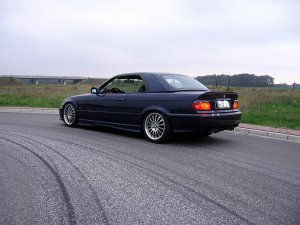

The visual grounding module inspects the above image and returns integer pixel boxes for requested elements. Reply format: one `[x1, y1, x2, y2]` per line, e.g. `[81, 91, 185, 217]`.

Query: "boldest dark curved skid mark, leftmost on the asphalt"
[0, 137, 77, 225]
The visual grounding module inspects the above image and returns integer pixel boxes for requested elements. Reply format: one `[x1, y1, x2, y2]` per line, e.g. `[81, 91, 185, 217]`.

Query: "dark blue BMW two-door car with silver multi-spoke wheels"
[59, 73, 241, 143]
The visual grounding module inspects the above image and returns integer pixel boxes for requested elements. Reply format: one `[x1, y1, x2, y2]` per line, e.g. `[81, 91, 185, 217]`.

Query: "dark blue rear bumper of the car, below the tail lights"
[168, 111, 242, 132]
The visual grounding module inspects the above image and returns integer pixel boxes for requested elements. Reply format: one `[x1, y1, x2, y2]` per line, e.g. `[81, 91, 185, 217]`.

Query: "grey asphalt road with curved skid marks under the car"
[0, 113, 300, 225]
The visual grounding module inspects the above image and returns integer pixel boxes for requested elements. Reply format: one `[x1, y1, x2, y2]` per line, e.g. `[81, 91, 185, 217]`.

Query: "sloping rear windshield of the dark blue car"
[161, 74, 208, 91]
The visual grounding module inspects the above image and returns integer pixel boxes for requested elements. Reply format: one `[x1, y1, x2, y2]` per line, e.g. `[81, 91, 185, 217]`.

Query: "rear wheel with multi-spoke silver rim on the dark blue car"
[143, 112, 171, 143]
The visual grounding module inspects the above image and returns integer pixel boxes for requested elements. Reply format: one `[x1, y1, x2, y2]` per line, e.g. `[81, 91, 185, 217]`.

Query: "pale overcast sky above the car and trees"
[0, 0, 300, 83]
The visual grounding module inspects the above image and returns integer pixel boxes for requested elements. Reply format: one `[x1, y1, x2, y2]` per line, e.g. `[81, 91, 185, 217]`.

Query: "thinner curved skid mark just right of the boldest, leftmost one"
[8, 132, 109, 225]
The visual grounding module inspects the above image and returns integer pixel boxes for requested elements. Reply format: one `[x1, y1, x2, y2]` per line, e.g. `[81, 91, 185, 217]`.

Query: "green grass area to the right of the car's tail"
[210, 87, 300, 130]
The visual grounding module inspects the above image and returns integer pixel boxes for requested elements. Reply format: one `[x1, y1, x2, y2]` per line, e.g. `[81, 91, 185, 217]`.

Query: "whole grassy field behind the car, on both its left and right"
[0, 82, 300, 130]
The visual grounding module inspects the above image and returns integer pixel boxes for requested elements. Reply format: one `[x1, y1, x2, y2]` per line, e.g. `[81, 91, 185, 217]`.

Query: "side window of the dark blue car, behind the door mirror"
[100, 76, 145, 93]
